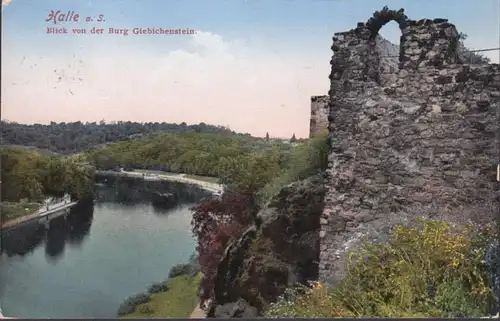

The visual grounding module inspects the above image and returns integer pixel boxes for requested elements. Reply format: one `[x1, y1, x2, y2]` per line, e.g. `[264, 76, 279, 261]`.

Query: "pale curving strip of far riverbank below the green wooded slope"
[97, 170, 223, 193]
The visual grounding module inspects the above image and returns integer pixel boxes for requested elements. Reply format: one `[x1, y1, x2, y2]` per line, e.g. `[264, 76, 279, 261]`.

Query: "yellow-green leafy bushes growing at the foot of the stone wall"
[266, 220, 495, 318]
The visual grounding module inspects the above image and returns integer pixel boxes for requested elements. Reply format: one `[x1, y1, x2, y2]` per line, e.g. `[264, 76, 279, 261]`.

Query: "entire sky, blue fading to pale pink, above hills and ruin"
[2, 0, 500, 136]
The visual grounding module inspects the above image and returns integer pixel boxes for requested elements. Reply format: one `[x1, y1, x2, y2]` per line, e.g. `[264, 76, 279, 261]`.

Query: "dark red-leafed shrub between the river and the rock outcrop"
[191, 192, 254, 300]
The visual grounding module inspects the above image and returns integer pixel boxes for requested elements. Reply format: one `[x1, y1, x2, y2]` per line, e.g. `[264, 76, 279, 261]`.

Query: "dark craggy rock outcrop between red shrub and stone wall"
[208, 176, 326, 317]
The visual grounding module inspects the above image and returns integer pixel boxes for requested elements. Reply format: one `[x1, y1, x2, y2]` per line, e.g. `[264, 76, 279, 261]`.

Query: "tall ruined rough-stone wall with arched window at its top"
[319, 8, 500, 283]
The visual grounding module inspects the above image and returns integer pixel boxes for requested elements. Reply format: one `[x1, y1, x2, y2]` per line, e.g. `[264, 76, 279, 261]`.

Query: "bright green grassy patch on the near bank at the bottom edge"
[124, 273, 202, 318]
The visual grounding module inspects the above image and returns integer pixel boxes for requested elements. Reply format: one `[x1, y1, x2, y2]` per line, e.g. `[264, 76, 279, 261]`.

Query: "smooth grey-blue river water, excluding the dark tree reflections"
[0, 184, 199, 318]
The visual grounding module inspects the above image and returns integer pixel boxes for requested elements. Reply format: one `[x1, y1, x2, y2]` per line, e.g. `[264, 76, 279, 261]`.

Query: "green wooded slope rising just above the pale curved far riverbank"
[85, 133, 293, 177]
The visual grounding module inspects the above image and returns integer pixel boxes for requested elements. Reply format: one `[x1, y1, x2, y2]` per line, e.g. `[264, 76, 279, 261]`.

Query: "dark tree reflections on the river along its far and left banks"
[0, 177, 210, 262]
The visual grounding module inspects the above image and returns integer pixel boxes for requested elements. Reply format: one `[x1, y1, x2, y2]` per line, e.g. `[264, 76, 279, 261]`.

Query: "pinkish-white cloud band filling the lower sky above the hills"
[2, 32, 330, 137]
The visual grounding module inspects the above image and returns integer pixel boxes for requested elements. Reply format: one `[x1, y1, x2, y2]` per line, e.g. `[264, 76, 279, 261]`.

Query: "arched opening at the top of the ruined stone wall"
[374, 21, 401, 78]
